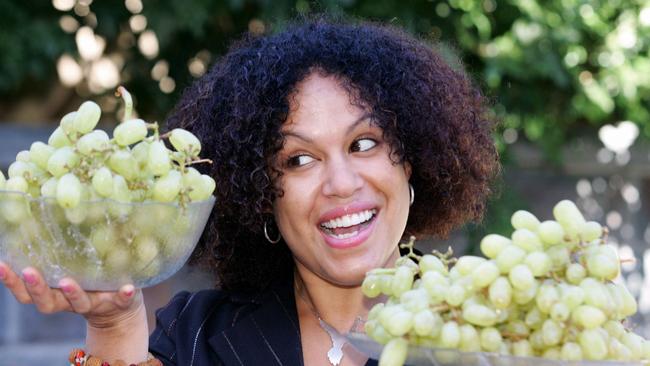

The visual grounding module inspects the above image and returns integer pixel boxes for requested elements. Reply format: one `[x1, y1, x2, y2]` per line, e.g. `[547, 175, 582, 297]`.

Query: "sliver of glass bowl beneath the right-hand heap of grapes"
[345, 332, 647, 366]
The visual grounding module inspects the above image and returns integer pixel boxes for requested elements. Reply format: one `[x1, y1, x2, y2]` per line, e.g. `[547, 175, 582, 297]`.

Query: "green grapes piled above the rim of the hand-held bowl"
[0, 88, 215, 209]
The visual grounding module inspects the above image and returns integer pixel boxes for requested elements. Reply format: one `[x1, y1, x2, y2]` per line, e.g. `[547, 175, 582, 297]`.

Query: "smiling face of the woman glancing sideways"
[274, 73, 410, 286]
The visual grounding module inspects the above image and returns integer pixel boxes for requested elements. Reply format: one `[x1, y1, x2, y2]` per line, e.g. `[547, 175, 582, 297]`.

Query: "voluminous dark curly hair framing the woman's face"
[167, 18, 499, 291]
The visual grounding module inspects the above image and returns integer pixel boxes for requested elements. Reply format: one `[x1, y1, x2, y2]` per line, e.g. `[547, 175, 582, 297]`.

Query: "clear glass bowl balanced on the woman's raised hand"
[0, 190, 215, 291]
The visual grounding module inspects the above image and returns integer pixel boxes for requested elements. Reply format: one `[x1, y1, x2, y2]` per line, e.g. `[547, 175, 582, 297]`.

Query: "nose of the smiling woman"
[323, 157, 363, 198]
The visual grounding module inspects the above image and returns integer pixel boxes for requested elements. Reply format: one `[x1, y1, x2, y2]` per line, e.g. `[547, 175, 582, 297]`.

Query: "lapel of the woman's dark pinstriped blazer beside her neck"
[208, 279, 303, 366]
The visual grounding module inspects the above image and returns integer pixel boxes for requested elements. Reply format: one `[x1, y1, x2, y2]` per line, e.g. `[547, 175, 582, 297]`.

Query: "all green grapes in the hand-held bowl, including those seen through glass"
[0, 87, 215, 284]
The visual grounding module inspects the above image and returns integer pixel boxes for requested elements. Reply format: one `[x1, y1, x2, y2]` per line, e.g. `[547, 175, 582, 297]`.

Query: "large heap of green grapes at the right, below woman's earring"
[362, 200, 650, 366]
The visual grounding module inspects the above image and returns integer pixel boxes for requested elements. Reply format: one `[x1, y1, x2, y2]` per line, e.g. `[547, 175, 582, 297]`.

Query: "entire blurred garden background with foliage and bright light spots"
[0, 0, 650, 363]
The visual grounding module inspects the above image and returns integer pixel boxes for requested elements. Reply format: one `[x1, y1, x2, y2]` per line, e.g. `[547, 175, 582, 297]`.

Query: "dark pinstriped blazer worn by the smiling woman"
[149, 278, 377, 366]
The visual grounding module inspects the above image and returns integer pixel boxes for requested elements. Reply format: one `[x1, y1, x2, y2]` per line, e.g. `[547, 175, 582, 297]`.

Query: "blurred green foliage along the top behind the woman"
[0, 0, 650, 244]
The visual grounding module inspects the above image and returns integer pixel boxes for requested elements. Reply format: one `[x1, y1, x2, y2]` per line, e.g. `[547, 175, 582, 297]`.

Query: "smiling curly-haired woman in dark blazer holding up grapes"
[0, 20, 498, 365]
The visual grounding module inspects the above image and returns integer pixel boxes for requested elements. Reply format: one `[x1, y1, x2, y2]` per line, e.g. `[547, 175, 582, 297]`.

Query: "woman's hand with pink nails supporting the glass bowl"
[0, 262, 143, 328]
